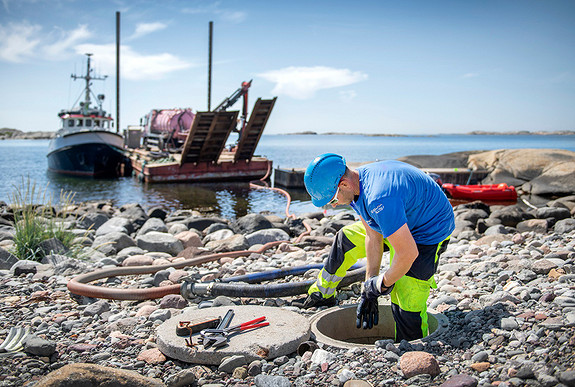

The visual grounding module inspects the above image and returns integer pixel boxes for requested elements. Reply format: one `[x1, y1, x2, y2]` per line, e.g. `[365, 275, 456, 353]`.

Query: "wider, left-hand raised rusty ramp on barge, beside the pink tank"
[180, 111, 238, 165]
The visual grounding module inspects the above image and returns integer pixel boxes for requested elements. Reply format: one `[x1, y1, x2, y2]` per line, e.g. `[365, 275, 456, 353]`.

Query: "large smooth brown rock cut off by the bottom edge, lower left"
[34, 363, 165, 387]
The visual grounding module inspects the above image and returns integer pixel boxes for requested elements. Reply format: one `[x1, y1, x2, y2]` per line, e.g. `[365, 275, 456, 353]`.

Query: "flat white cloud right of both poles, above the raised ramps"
[259, 66, 368, 99]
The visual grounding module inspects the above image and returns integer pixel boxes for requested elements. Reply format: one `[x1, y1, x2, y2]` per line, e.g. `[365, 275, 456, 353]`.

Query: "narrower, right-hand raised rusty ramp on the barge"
[234, 97, 277, 161]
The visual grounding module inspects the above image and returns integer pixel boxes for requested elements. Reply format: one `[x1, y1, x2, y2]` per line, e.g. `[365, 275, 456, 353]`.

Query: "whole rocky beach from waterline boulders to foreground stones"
[0, 149, 575, 387]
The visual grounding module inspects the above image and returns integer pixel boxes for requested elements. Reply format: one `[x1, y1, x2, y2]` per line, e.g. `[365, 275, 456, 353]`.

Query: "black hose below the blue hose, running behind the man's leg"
[180, 267, 365, 300]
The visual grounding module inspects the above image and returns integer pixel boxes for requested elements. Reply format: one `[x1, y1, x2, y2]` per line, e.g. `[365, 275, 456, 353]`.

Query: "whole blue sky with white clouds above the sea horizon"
[0, 0, 575, 135]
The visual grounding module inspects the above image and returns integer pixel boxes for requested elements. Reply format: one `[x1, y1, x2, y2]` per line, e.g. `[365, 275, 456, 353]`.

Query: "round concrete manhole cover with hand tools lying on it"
[156, 305, 311, 365]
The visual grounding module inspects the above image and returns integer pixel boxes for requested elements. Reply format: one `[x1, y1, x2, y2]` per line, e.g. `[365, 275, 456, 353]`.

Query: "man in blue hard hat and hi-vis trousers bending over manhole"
[304, 153, 455, 341]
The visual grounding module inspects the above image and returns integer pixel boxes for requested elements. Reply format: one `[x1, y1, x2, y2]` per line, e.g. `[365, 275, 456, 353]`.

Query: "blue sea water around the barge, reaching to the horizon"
[0, 135, 575, 219]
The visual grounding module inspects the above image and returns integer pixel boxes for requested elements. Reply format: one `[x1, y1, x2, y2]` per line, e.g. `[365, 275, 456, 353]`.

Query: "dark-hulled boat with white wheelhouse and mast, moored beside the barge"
[47, 54, 129, 178]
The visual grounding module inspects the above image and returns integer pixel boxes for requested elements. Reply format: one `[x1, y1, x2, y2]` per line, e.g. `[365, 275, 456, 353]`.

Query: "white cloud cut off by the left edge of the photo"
[0, 22, 42, 63]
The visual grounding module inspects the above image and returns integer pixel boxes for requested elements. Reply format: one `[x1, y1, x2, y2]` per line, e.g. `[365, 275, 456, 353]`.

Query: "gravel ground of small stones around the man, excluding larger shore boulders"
[0, 202, 575, 387]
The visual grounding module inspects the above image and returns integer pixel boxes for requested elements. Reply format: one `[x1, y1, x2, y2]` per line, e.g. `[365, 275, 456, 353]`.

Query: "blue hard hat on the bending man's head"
[303, 153, 346, 207]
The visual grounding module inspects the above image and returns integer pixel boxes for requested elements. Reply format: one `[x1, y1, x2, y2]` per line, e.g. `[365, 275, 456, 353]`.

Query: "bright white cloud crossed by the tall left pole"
[72, 44, 192, 80]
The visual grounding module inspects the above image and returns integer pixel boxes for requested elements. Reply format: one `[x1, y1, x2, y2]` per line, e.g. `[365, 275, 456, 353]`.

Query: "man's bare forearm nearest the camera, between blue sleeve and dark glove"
[382, 223, 419, 286]
